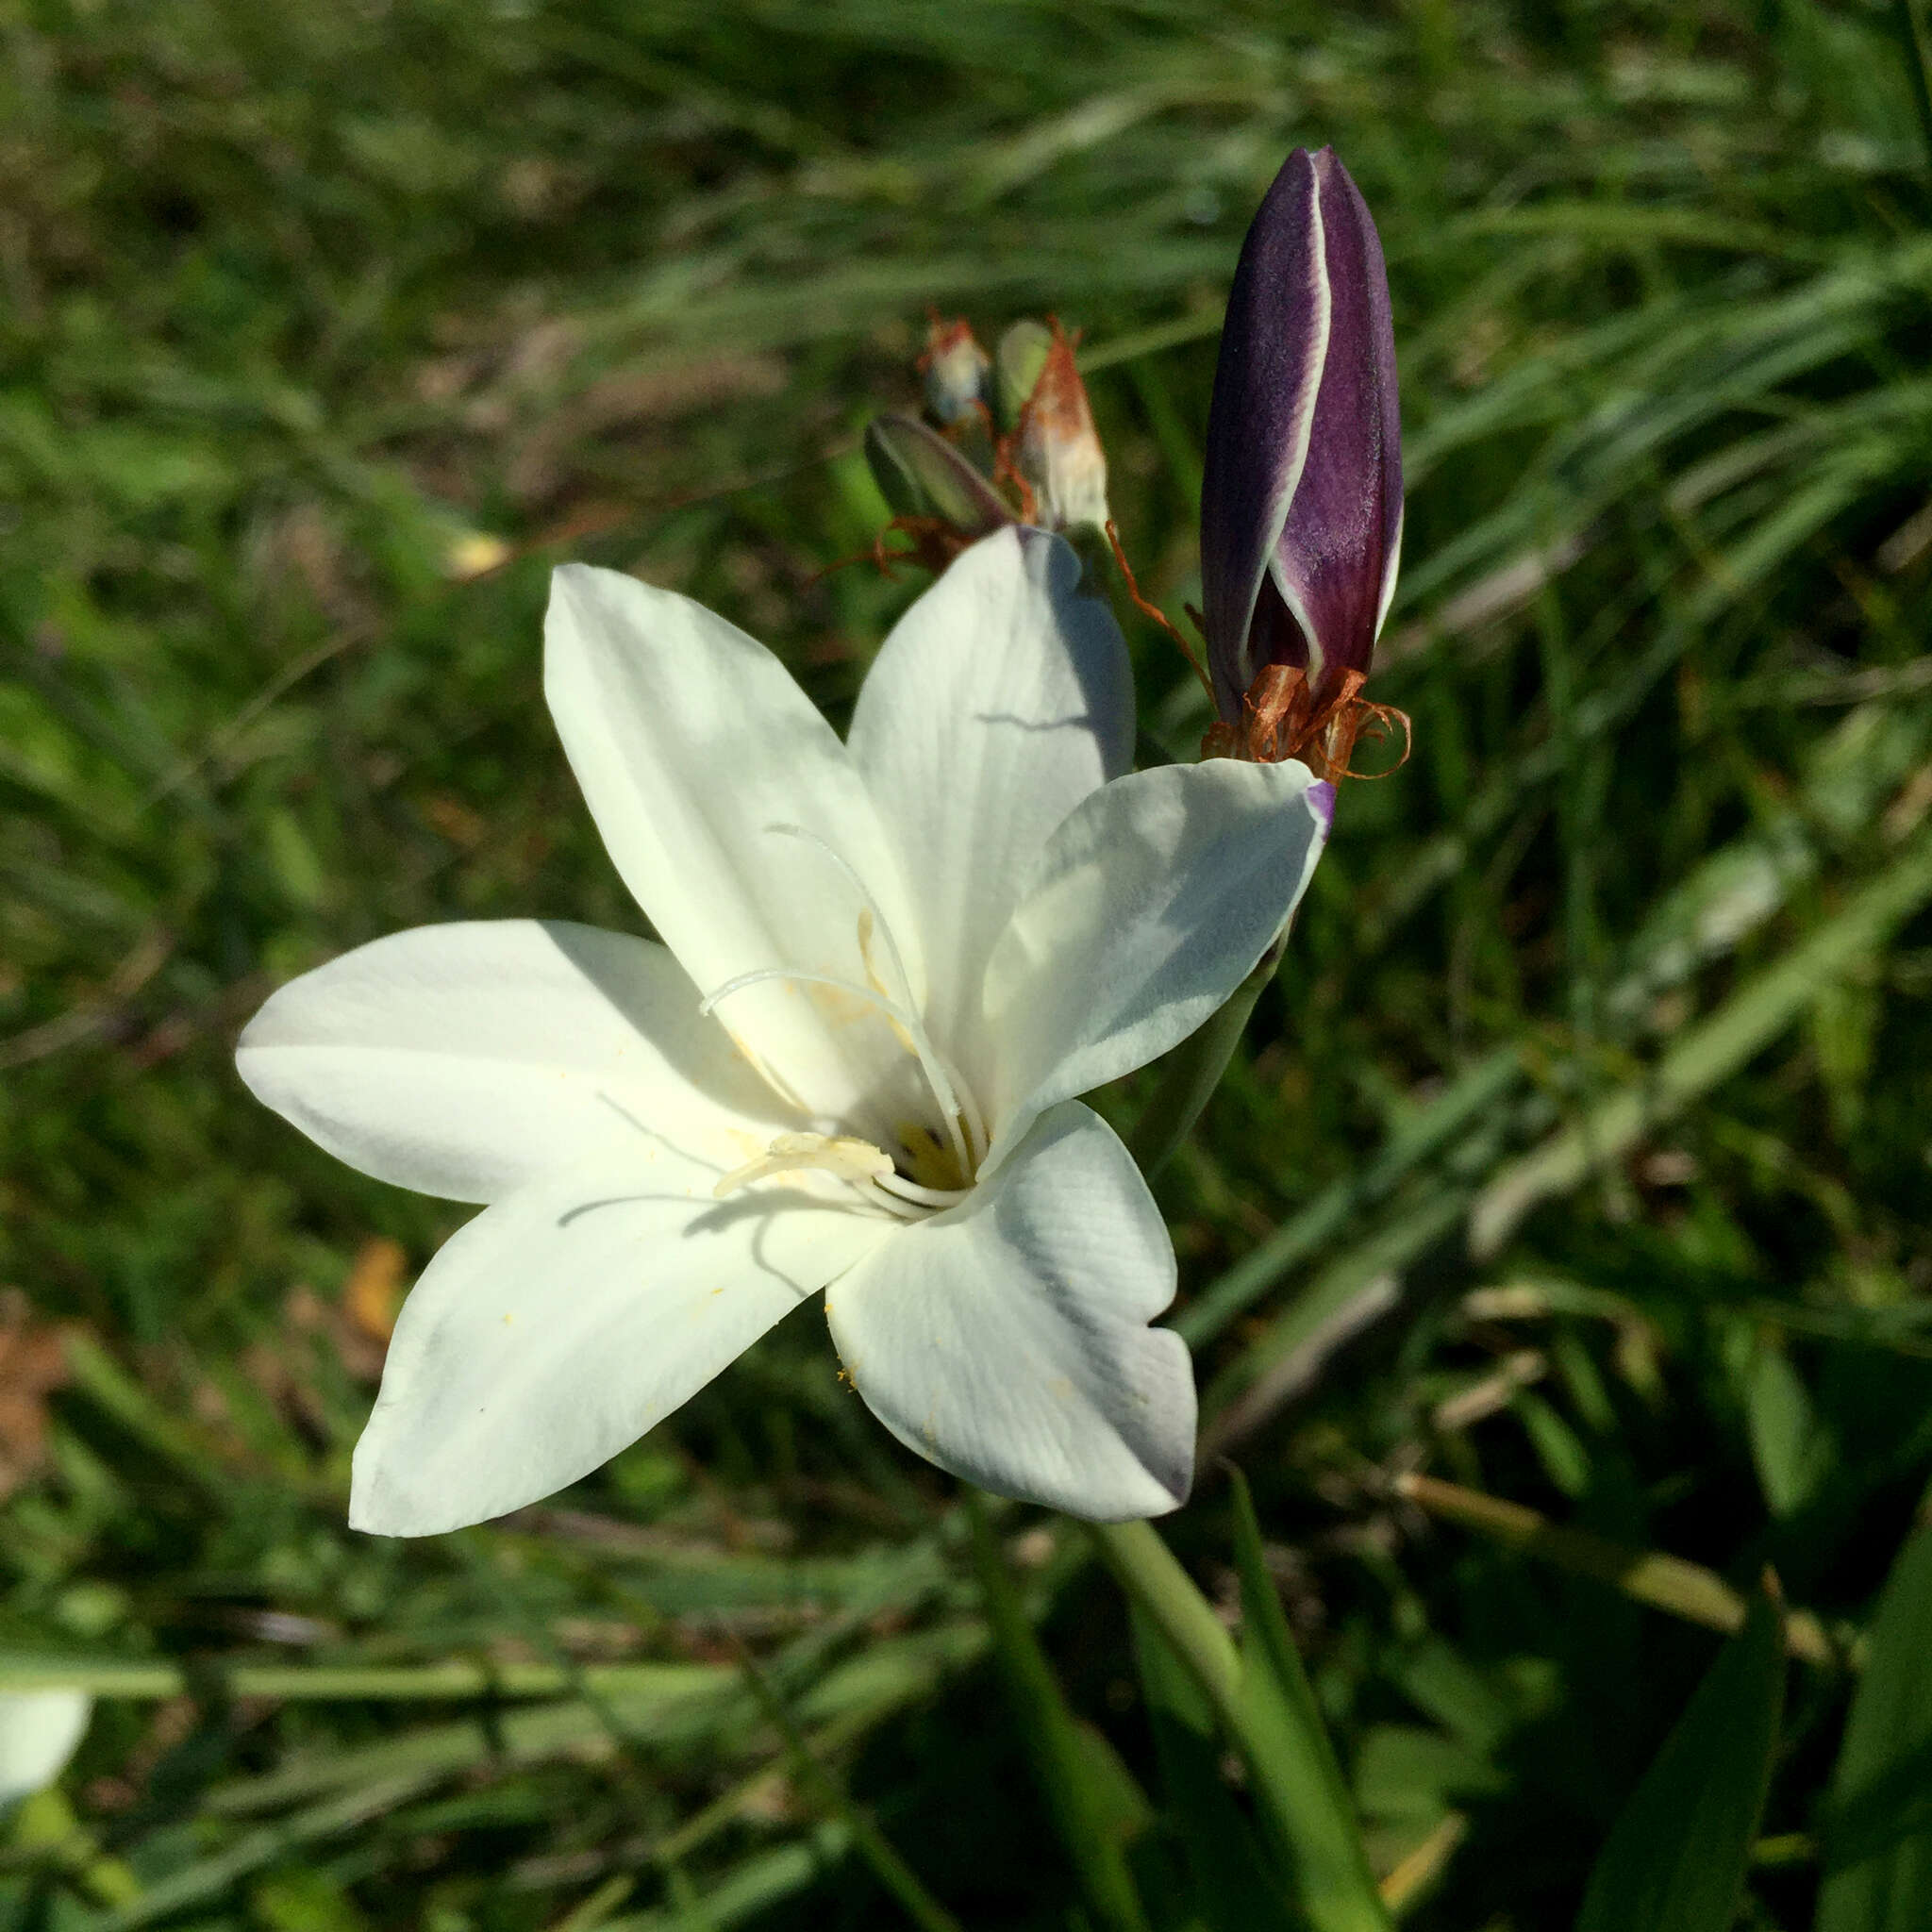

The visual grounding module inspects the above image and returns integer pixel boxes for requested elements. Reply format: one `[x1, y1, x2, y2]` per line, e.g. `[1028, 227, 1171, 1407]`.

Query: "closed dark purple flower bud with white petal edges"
[1202, 149, 1403, 728]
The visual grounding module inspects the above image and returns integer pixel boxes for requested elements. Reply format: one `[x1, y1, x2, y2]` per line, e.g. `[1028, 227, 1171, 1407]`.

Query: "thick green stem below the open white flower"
[1090, 1523, 1390, 1932]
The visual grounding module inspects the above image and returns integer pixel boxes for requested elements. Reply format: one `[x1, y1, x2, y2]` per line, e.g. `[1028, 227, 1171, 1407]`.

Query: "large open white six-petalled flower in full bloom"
[238, 529, 1329, 1536]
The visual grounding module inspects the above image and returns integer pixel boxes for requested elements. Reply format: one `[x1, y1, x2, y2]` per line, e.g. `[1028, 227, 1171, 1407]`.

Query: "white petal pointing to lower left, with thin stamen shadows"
[350, 1156, 900, 1536]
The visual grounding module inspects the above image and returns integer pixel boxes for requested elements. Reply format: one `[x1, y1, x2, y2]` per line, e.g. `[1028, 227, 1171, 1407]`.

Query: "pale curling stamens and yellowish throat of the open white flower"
[697, 824, 988, 1219]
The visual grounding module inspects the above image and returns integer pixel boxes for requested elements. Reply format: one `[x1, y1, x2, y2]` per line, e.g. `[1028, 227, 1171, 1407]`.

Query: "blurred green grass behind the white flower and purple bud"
[0, 0, 1932, 1932]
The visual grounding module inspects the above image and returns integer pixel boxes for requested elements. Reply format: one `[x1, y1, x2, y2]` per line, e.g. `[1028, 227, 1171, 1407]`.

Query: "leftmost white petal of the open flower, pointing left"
[236, 920, 796, 1202]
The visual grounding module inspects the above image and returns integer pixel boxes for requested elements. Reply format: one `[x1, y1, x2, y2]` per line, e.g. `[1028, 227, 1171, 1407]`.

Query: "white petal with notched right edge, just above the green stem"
[824, 1105, 1194, 1523]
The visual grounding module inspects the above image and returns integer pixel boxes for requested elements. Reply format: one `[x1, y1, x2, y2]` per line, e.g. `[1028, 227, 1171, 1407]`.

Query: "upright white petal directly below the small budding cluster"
[850, 527, 1134, 1086]
